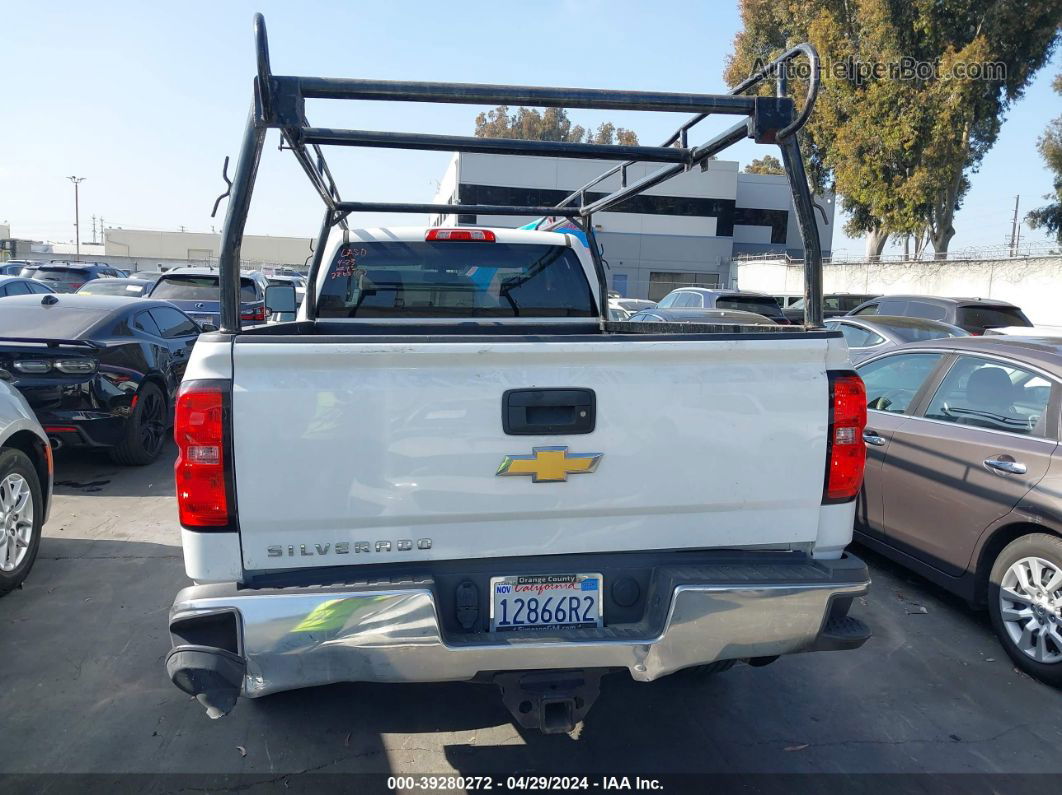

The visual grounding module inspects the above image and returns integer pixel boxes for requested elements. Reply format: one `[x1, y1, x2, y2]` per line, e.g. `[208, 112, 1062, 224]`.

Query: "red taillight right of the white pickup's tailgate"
[822, 370, 867, 505]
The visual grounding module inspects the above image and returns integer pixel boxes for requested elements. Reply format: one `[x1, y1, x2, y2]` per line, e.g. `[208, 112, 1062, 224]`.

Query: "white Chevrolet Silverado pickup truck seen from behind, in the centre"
[167, 15, 869, 731]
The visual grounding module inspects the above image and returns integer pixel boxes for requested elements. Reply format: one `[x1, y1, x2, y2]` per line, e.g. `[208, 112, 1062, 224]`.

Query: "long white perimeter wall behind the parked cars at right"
[737, 256, 1062, 325]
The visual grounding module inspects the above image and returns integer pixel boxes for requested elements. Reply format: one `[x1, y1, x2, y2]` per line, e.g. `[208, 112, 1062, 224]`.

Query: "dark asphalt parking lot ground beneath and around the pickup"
[0, 449, 1062, 790]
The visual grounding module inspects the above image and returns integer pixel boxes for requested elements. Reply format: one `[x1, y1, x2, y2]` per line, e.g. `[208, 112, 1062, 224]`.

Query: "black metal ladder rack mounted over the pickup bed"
[219, 14, 822, 333]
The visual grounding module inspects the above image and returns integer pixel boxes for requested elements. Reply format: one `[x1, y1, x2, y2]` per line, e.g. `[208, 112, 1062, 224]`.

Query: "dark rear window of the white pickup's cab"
[318, 240, 597, 317]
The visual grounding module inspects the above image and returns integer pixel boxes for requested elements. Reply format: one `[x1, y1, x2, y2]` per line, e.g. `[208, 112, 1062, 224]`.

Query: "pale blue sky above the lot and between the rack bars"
[0, 0, 1062, 255]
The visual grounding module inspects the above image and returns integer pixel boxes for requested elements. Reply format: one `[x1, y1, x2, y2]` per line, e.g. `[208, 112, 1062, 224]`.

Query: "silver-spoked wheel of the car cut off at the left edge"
[0, 449, 45, 595]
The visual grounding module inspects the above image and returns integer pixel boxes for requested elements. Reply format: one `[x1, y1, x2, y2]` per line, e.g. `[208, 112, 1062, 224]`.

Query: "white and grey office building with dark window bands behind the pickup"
[431, 153, 834, 300]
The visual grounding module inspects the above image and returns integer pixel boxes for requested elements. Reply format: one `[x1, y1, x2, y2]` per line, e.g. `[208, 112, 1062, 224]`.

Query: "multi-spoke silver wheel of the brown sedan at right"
[989, 533, 1062, 687]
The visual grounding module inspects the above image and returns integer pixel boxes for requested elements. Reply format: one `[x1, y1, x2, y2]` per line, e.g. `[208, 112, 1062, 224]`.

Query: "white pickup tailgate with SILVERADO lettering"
[233, 335, 828, 571]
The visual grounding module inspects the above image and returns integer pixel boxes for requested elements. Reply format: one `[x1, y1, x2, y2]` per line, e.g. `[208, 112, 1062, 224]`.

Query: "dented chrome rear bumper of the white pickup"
[168, 557, 869, 701]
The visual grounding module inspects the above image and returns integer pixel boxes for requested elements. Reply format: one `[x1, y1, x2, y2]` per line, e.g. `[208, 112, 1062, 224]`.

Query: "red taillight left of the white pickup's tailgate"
[173, 381, 229, 528]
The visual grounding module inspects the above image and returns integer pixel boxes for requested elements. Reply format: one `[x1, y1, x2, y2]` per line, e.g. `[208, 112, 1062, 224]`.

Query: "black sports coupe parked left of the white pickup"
[0, 295, 201, 464]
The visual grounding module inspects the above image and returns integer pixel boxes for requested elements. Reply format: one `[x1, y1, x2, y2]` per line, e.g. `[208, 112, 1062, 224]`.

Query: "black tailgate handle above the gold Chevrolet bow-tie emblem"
[501, 387, 597, 436]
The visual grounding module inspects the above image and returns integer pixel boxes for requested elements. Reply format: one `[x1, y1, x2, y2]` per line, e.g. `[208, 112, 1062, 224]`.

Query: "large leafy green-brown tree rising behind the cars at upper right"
[725, 0, 1062, 257]
